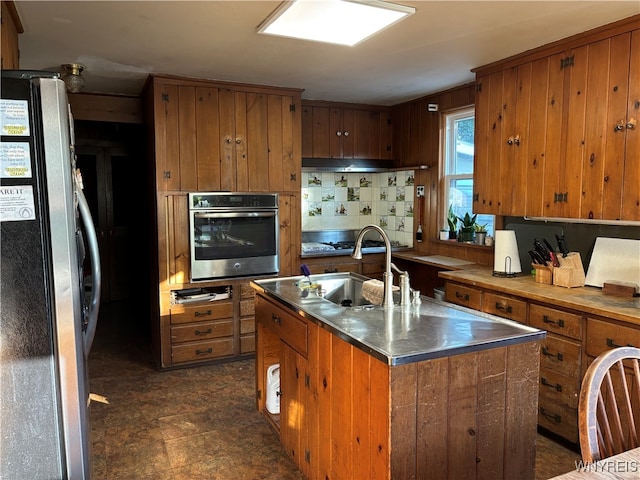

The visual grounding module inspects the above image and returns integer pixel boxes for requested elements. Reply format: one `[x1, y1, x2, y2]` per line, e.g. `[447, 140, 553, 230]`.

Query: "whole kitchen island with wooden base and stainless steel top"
[251, 274, 545, 479]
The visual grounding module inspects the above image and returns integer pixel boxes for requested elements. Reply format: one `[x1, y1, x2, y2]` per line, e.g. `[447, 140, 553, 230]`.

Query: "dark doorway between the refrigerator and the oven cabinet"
[75, 121, 149, 303]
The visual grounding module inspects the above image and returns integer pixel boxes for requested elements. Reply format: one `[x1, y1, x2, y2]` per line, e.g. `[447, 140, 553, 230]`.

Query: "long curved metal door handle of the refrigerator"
[75, 186, 102, 358]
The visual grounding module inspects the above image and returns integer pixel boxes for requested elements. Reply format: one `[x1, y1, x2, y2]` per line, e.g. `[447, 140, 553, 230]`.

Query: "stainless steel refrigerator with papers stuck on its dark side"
[0, 70, 100, 480]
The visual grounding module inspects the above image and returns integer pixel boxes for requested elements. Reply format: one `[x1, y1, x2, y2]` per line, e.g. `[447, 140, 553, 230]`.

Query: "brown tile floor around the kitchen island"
[89, 303, 579, 480]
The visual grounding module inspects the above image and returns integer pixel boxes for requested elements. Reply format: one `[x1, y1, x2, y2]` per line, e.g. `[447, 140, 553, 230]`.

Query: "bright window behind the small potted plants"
[443, 108, 495, 235]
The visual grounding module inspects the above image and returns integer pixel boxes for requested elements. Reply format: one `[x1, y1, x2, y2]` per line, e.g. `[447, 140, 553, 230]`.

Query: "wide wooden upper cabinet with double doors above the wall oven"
[150, 77, 301, 192]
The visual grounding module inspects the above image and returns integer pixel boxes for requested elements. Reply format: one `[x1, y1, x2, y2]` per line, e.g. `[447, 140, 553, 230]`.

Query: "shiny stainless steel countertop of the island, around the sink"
[251, 274, 546, 365]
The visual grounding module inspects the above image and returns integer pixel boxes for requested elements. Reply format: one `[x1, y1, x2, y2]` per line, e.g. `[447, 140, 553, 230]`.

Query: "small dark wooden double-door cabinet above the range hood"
[302, 102, 392, 160]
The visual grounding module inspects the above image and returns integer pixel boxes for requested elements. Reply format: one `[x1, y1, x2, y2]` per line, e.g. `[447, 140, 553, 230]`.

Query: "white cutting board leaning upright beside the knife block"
[585, 237, 640, 288]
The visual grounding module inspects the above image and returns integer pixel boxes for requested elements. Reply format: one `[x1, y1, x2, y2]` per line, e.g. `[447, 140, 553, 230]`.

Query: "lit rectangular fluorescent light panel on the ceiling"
[258, 0, 416, 46]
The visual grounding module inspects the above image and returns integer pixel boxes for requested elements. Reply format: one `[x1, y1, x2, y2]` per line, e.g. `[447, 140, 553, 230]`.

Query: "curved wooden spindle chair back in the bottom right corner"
[578, 347, 640, 462]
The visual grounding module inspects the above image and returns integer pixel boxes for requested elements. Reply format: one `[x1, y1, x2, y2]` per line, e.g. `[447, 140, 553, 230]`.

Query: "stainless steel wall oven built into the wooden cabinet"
[189, 192, 279, 281]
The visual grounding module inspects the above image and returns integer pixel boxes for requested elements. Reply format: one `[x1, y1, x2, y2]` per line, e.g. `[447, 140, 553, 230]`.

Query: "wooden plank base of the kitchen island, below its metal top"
[256, 294, 539, 480]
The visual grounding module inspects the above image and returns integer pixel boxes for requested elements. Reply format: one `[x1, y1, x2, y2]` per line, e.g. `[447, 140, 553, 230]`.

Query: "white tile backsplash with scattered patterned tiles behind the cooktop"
[302, 170, 415, 246]
